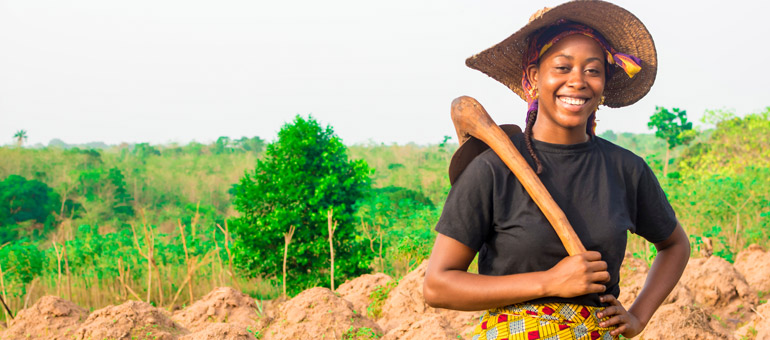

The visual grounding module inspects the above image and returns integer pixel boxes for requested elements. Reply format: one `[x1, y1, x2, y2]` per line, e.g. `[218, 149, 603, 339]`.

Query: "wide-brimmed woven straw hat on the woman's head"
[465, 0, 658, 107]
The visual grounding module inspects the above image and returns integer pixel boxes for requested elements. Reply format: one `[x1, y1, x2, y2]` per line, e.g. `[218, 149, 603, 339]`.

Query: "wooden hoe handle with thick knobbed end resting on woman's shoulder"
[452, 96, 586, 255]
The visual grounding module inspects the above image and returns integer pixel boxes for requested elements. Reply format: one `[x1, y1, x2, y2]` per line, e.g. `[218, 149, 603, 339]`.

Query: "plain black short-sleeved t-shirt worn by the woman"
[436, 134, 677, 306]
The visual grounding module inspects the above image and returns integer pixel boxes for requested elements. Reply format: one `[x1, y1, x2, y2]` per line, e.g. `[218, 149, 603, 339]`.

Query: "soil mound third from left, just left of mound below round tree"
[171, 287, 259, 332]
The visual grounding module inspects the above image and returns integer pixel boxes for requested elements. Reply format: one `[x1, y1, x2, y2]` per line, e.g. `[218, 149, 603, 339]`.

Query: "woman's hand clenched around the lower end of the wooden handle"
[546, 251, 610, 298]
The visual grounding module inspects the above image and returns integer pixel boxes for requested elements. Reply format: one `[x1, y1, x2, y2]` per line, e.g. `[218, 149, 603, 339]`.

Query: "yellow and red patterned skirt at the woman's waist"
[471, 303, 618, 340]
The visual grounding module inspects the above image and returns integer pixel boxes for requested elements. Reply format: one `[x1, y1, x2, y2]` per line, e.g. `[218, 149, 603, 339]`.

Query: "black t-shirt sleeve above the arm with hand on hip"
[635, 163, 677, 243]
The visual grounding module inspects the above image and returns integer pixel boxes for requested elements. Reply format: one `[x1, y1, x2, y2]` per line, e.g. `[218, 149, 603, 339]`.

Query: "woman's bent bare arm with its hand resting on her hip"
[599, 223, 690, 338]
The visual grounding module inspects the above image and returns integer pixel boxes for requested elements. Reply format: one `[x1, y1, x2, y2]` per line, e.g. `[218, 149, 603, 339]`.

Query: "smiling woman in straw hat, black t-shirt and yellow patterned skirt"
[423, 0, 689, 340]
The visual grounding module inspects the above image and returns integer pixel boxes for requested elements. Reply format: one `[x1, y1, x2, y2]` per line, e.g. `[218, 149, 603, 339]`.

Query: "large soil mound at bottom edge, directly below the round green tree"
[260, 287, 382, 340]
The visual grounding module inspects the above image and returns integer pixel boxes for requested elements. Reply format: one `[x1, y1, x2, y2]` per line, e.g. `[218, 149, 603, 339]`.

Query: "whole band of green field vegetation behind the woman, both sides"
[0, 109, 770, 326]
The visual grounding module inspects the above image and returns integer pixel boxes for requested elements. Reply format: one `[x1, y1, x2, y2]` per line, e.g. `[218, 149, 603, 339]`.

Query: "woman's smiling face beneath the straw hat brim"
[527, 34, 606, 136]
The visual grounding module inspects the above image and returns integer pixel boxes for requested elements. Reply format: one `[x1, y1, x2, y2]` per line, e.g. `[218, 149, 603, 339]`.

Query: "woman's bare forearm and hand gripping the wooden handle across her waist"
[423, 234, 610, 310]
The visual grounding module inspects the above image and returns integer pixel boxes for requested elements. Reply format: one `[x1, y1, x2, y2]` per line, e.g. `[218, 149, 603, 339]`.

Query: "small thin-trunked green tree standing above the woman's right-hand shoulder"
[647, 106, 696, 177]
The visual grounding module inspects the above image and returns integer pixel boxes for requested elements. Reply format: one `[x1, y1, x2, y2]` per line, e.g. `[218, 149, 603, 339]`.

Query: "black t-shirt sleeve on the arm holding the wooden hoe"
[436, 157, 494, 251]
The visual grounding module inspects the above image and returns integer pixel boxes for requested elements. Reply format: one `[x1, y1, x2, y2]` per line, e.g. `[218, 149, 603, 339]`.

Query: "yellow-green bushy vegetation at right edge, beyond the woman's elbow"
[662, 108, 770, 262]
